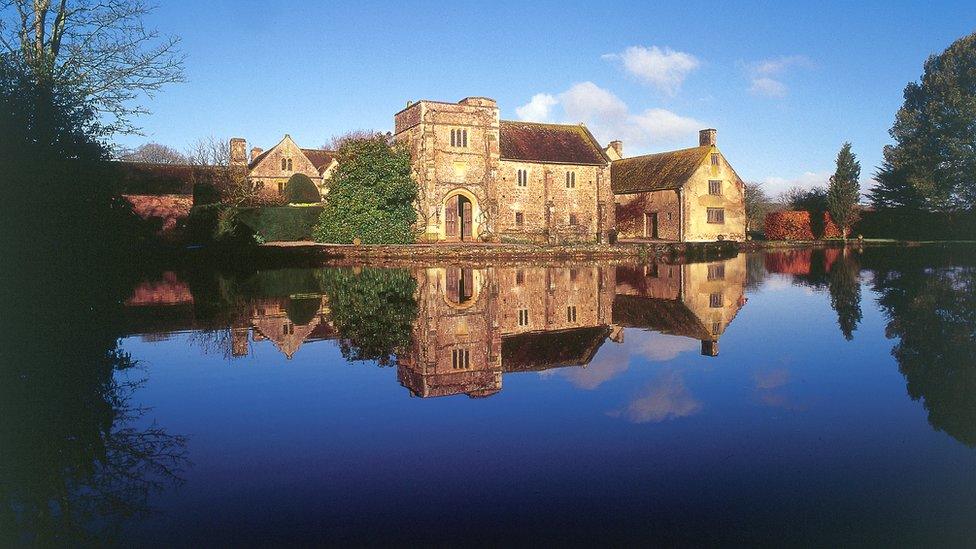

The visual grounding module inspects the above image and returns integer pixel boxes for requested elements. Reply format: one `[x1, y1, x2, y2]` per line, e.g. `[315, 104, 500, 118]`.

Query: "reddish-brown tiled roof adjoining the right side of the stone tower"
[499, 120, 610, 165]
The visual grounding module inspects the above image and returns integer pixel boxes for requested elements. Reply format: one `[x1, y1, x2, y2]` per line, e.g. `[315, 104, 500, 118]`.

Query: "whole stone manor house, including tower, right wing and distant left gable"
[231, 97, 745, 243]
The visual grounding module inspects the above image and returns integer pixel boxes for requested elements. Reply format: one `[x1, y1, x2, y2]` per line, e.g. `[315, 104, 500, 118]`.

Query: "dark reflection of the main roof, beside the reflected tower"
[502, 326, 610, 372]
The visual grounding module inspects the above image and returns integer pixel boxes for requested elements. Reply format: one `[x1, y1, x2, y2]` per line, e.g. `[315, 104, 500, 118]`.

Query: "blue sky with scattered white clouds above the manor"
[119, 0, 976, 194]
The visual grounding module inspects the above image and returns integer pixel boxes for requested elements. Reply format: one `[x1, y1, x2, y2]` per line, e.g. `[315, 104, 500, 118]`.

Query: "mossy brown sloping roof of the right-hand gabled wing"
[610, 146, 712, 194]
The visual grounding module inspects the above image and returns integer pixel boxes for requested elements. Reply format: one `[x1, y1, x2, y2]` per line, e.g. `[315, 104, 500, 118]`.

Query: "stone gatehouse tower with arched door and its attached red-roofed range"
[394, 97, 613, 242]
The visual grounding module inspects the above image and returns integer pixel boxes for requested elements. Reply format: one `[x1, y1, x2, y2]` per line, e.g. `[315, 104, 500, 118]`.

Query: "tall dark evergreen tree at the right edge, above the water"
[870, 34, 976, 212]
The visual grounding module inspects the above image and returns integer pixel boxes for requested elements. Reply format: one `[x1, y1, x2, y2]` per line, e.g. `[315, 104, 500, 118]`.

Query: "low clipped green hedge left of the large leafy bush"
[187, 204, 322, 244]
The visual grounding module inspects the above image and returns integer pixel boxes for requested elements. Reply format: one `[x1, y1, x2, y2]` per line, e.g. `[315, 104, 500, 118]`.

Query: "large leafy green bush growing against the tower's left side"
[313, 136, 417, 244]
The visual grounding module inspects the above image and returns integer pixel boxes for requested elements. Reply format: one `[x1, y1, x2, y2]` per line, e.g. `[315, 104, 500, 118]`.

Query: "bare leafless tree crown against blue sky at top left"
[0, 0, 184, 134]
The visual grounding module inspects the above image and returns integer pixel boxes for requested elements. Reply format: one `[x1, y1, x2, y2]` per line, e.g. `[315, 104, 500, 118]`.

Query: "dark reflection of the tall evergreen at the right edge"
[866, 248, 976, 446]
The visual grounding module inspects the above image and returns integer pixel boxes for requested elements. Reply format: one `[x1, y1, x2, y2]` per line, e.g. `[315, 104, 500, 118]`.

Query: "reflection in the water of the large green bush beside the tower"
[318, 268, 417, 365]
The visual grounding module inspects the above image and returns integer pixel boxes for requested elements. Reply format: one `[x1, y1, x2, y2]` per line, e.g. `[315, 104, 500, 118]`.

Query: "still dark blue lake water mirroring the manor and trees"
[0, 247, 976, 546]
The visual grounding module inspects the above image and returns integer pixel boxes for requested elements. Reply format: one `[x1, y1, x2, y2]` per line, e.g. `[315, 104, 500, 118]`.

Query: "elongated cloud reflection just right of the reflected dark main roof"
[542, 330, 699, 390]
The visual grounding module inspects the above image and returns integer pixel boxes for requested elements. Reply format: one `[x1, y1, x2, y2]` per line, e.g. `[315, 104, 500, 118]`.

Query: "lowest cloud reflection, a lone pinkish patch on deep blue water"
[610, 369, 702, 423]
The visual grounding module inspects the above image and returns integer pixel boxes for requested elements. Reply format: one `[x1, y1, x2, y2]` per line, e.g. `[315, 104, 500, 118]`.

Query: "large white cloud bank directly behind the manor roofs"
[515, 82, 706, 150]
